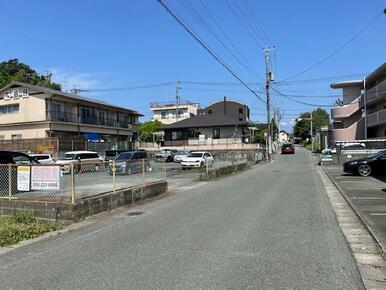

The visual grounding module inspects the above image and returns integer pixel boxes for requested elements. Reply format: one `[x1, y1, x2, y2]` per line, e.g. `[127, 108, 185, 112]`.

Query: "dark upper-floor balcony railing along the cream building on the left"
[47, 111, 132, 129]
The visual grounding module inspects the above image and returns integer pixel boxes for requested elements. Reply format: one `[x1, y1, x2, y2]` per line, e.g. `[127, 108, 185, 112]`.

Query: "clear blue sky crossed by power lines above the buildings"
[0, 0, 386, 129]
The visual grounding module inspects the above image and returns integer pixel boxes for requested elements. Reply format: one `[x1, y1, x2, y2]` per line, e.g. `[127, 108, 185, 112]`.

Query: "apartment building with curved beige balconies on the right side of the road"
[330, 63, 386, 143]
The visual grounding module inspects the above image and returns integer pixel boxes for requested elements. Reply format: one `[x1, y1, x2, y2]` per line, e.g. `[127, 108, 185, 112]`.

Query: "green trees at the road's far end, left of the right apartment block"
[293, 108, 330, 140]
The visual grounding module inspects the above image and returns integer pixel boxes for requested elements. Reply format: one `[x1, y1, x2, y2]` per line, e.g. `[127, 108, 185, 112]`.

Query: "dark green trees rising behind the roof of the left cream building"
[0, 58, 61, 90]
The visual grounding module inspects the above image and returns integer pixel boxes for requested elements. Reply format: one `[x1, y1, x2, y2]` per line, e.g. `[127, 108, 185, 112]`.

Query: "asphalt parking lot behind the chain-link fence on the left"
[0, 160, 199, 201]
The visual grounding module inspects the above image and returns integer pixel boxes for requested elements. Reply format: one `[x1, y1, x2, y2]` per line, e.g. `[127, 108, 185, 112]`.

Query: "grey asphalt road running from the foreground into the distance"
[0, 150, 363, 289]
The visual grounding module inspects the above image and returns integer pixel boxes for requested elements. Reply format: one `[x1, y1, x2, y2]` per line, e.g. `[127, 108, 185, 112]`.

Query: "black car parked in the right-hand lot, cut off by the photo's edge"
[343, 150, 386, 176]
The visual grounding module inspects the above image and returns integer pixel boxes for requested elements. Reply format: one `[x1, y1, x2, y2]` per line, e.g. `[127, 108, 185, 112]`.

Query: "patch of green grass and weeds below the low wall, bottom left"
[0, 209, 63, 247]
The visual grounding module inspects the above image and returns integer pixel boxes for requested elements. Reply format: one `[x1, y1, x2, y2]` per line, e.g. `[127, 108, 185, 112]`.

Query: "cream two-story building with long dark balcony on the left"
[0, 82, 142, 148]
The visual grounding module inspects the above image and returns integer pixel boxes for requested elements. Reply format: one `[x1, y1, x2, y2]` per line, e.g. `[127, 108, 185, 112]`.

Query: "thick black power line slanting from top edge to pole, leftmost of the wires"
[156, 0, 278, 113]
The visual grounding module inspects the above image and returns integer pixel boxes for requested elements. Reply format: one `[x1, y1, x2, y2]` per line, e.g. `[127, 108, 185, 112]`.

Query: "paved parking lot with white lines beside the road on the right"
[325, 166, 386, 251]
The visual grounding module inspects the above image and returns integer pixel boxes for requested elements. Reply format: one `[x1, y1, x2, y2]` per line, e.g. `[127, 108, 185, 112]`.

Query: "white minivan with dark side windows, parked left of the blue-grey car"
[56, 151, 103, 173]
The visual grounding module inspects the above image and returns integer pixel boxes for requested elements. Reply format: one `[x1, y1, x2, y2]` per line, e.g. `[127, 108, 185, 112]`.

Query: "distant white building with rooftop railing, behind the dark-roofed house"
[150, 101, 200, 125]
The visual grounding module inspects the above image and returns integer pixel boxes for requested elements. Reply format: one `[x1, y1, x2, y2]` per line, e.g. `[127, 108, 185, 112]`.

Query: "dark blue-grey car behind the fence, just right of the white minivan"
[109, 151, 151, 175]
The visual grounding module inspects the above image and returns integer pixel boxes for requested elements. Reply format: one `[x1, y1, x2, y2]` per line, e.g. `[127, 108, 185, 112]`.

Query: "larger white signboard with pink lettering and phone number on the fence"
[31, 166, 60, 190]
